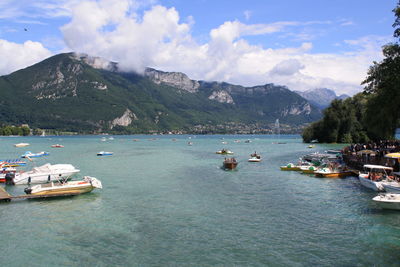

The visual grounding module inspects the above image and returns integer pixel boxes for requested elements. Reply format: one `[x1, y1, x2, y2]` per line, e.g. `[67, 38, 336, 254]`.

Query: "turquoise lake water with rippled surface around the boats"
[0, 136, 400, 266]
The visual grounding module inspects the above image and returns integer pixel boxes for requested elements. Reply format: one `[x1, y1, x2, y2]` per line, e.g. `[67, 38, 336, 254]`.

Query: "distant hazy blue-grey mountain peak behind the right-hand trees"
[294, 88, 350, 109]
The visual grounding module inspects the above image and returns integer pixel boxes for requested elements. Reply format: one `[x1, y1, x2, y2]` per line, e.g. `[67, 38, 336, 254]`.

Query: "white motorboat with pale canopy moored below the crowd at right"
[358, 164, 393, 192]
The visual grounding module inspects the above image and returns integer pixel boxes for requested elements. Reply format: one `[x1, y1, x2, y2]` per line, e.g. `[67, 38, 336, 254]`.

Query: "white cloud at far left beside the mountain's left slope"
[0, 39, 52, 75]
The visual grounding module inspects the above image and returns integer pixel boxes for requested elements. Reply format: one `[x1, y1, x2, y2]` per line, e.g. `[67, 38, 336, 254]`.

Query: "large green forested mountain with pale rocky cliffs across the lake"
[0, 53, 320, 133]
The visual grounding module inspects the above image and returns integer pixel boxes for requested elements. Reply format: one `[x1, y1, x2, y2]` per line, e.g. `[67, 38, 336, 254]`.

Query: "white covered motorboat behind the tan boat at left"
[13, 163, 80, 184]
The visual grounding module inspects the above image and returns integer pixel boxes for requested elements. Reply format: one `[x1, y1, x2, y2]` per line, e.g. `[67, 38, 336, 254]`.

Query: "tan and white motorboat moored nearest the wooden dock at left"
[24, 176, 103, 196]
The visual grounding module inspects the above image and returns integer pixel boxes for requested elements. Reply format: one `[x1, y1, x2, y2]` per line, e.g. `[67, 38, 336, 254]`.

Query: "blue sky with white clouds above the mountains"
[0, 0, 397, 94]
